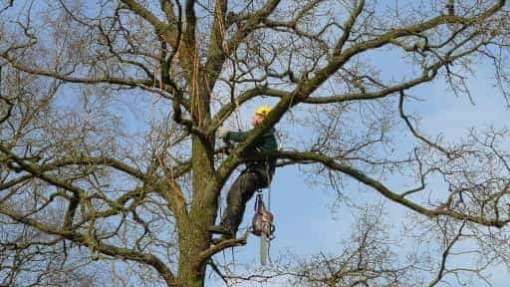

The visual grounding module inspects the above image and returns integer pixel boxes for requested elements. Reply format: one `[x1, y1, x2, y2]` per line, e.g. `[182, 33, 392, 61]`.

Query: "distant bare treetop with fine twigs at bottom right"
[213, 205, 500, 287]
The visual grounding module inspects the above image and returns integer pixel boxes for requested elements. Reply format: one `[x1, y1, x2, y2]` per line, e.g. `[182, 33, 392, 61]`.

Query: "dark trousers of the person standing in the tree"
[221, 170, 269, 234]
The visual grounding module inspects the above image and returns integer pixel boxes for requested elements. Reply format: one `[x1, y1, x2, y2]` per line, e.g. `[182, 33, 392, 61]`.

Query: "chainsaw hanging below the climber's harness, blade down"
[251, 190, 276, 265]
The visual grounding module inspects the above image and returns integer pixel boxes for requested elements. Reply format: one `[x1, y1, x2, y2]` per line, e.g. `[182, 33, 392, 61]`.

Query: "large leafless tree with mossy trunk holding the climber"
[0, 0, 510, 286]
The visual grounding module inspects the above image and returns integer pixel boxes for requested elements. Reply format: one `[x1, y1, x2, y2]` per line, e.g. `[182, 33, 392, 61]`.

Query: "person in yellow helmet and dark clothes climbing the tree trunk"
[209, 106, 278, 238]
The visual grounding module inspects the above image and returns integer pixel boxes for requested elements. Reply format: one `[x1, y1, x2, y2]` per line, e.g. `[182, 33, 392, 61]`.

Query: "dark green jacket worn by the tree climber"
[225, 128, 278, 182]
